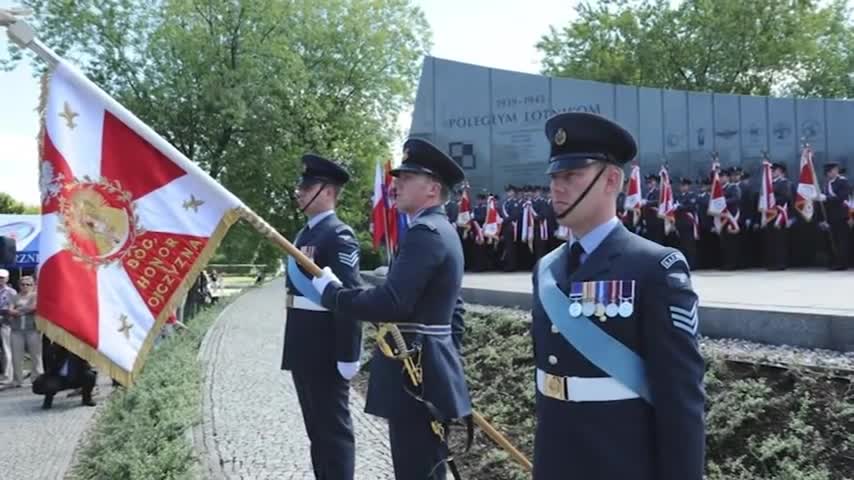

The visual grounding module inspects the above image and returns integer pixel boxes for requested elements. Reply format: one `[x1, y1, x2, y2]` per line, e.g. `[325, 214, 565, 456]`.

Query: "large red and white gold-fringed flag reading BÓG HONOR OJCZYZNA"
[37, 62, 243, 384]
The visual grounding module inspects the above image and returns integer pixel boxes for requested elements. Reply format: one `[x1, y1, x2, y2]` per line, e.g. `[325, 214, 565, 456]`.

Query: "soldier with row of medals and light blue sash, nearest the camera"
[531, 112, 705, 480]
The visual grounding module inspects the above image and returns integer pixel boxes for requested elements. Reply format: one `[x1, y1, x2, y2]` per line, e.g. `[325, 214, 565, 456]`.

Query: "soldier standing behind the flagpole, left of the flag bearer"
[282, 155, 362, 480]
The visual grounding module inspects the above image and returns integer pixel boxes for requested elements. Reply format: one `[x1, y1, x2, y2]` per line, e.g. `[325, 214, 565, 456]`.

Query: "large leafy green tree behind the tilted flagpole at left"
[5, 0, 429, 264]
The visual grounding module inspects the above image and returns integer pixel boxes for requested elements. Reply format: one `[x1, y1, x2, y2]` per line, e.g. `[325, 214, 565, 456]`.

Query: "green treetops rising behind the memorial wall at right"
[537, 0, 854, 97]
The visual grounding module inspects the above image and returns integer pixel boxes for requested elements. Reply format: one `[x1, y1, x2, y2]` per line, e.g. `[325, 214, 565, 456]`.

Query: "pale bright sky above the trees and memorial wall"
[0, 0, 579, 205]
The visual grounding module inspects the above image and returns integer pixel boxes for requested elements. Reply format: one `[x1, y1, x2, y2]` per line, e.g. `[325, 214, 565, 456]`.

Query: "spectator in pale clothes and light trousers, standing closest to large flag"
[6, 275, 44, 387]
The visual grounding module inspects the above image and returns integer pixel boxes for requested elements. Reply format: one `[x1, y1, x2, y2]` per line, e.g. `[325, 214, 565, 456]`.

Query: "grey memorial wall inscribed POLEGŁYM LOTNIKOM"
[410, 57, 854, 192]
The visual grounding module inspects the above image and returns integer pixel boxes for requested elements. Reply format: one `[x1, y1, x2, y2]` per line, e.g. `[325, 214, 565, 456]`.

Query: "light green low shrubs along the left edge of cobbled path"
[71, 304, 225, 480]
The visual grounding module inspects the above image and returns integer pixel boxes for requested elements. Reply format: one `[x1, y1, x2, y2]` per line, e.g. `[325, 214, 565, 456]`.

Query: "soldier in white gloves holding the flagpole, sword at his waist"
[312, 138, 471, 480]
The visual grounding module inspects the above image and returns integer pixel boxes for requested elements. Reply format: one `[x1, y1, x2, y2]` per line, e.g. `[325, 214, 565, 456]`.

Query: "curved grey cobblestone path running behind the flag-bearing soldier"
[194, 278, 393, 480]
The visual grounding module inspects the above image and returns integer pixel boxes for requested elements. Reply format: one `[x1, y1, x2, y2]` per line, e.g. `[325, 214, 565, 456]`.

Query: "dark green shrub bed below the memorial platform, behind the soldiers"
[448, 306, 854, 480]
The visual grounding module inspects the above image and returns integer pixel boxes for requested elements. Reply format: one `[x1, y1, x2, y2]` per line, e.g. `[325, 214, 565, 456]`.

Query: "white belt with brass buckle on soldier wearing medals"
[537, 368, 640, 402]
